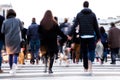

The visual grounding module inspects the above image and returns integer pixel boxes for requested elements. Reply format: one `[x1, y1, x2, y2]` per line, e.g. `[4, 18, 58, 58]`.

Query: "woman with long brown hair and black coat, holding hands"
[38, 10, 67, 73]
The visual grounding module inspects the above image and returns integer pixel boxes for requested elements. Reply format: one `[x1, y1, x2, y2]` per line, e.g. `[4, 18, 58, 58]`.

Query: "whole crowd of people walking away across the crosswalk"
[0, 1, 120, 74]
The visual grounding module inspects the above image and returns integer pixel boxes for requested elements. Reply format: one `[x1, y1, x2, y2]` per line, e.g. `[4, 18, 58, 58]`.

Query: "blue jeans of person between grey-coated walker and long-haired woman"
[30, 40, 40, 60]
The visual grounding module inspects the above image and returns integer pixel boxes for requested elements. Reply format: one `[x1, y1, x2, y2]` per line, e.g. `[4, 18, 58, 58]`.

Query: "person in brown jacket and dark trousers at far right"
[108, 22, 120, 64]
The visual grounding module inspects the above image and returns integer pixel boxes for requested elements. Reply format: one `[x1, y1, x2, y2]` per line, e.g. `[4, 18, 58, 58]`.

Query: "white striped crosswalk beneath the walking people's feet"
[0, 60, 120, 80]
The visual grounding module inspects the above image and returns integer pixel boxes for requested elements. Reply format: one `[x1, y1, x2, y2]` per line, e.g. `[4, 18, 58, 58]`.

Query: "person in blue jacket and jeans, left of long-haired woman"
[27, 18, 40, 64]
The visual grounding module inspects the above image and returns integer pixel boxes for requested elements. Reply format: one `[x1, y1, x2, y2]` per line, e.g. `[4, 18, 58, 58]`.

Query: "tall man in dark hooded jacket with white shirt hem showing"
[70, 1, 100, 72]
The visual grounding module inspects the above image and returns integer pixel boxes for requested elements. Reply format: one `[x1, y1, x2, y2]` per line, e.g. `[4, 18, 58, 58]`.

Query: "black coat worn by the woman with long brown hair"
[38, 25, 67, 53]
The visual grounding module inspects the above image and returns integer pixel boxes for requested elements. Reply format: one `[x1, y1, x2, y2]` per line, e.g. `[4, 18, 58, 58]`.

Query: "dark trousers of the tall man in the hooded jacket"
[81, 38, 95, 69]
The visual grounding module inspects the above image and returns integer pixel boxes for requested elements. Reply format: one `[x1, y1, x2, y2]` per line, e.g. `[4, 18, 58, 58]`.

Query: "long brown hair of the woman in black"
[40, 10, 57, 30]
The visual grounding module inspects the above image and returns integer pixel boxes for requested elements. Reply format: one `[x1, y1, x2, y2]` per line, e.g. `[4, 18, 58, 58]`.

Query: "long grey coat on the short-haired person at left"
[1, 17, 23, 54]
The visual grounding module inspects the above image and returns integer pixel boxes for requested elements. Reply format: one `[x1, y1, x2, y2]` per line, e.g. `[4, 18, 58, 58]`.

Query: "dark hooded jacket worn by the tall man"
[71, 8, 100, 39]
